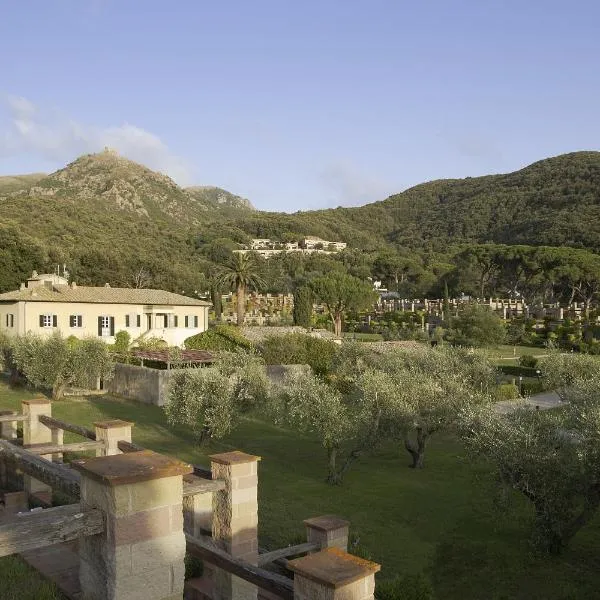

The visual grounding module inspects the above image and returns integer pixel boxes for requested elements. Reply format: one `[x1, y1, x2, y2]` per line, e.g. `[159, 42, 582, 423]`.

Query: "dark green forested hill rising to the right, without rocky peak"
[230, 152, 600, 251]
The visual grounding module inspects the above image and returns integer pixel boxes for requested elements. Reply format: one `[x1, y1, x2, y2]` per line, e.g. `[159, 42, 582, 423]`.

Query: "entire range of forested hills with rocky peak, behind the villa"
[0, 151, 600, 295]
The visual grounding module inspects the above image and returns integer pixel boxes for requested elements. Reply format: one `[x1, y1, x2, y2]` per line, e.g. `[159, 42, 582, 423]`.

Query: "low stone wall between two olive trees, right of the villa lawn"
[106, 363, 172, 406]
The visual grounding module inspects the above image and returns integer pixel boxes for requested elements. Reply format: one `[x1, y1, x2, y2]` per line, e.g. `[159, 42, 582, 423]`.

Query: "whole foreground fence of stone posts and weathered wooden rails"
[0, 398, 379, 600]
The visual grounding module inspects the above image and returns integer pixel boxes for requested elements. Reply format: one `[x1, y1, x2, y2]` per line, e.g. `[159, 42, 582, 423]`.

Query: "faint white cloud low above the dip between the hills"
[319, 162, 395, 206]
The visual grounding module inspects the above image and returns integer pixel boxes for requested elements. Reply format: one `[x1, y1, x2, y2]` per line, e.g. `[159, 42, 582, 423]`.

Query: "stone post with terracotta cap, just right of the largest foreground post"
[210, 451, 260, 600]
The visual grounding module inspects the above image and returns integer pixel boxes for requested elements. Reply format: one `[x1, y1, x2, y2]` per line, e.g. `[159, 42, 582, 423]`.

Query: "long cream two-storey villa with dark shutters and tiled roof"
[0, 271, 211, 346]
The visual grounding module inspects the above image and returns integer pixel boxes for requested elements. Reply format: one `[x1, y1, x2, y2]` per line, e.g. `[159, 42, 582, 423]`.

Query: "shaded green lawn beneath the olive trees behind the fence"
[0, 383, 600, 600]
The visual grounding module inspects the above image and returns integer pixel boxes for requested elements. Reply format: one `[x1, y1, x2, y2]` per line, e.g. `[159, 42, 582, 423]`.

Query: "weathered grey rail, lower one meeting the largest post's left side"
[0, 504, 104, 558]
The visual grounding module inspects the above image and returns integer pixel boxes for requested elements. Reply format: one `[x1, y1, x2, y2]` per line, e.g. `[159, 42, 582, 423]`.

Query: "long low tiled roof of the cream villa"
[0, 285, 210, 306]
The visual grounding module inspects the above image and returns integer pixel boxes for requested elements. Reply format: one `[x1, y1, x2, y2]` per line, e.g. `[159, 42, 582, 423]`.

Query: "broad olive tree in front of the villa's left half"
[11, 334, 113, 400]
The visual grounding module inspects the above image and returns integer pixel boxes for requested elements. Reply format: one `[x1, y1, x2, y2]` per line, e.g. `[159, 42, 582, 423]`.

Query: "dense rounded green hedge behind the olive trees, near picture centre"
[260, 333, 338, 375]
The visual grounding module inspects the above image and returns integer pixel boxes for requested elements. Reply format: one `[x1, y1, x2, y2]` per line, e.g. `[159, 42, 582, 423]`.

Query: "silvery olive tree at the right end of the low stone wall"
[165, 352, 269, 443]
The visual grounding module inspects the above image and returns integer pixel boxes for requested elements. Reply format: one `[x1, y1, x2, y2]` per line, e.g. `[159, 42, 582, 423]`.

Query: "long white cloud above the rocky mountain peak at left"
[0, 96, 191, 185]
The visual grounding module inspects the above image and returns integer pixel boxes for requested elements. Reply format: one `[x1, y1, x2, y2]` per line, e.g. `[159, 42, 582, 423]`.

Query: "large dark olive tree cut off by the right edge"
[464, 390, 600, 554]
